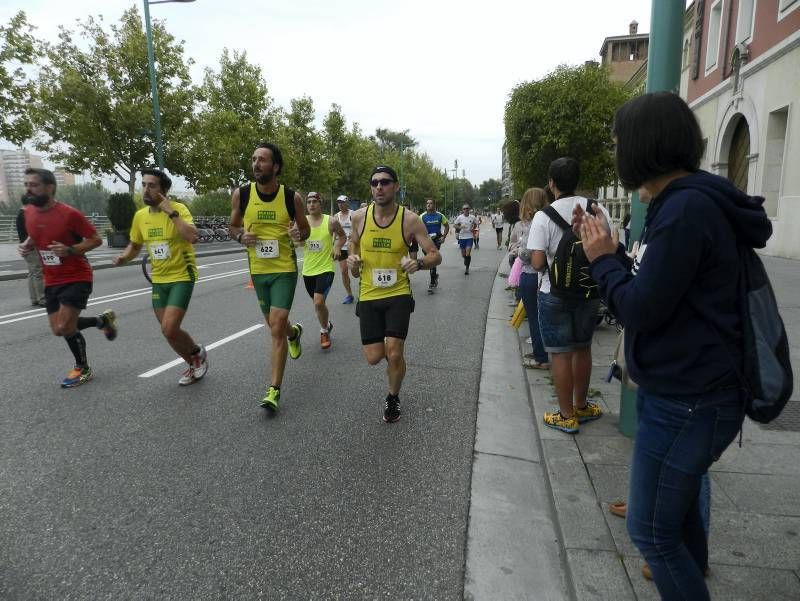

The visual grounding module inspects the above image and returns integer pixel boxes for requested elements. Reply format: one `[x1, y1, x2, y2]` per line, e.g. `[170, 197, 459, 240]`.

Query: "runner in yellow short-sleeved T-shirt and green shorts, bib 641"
[112, 169, 208, 386]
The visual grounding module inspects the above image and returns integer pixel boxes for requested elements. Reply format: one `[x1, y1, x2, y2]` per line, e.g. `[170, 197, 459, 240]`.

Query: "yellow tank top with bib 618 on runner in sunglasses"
[359, 204, 411, 301]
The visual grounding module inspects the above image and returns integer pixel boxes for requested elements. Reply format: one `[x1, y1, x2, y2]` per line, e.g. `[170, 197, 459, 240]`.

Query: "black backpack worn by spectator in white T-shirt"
[542, 200, 600, 300]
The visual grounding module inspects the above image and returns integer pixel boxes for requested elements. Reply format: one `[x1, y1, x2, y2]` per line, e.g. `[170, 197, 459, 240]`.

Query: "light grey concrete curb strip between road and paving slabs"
[464, 255, 576, 601]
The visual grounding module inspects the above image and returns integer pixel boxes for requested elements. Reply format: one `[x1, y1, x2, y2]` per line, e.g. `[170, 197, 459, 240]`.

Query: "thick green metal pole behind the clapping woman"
[619, 0, 686, 437]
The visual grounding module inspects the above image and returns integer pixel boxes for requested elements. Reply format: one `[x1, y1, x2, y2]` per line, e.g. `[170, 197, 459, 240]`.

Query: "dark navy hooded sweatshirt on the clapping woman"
[591, 171, 772, 396]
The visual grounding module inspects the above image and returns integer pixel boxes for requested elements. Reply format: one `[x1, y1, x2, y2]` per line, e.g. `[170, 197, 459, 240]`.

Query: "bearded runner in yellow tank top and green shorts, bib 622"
[230, 142, 310, 411]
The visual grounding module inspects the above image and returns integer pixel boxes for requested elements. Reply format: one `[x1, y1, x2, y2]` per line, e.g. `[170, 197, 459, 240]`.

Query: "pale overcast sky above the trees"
[0, 0, 651, 190]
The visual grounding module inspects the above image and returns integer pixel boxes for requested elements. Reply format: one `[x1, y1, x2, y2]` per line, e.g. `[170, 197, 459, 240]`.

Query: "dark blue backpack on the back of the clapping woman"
[737, 245, 793, 424]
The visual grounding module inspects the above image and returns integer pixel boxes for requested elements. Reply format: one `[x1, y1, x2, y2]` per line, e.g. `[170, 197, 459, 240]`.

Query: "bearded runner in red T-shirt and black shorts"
[19, 168, 117, 388]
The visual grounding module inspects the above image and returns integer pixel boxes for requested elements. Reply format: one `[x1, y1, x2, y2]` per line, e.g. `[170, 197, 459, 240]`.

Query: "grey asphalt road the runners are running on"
[0, 231, 500, 600]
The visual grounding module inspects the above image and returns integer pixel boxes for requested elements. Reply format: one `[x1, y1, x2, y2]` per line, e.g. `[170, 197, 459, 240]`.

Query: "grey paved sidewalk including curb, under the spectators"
[465, 257, 800, 601]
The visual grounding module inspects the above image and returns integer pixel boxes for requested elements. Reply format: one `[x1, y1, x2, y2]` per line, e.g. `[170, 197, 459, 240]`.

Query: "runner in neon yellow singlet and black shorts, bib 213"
[303, 192, 346, 350]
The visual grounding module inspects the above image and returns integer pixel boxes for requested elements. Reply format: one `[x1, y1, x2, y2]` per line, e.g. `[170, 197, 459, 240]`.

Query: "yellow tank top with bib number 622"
[244, 182, 297, 275]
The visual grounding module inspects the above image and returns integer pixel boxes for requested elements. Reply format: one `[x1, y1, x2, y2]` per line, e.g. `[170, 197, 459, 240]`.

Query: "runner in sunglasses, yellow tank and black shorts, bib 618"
[347, 165, 442, 423]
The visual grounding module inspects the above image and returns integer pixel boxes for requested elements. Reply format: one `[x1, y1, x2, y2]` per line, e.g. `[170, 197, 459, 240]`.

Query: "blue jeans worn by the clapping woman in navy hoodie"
[627, 389, 743, 601]
